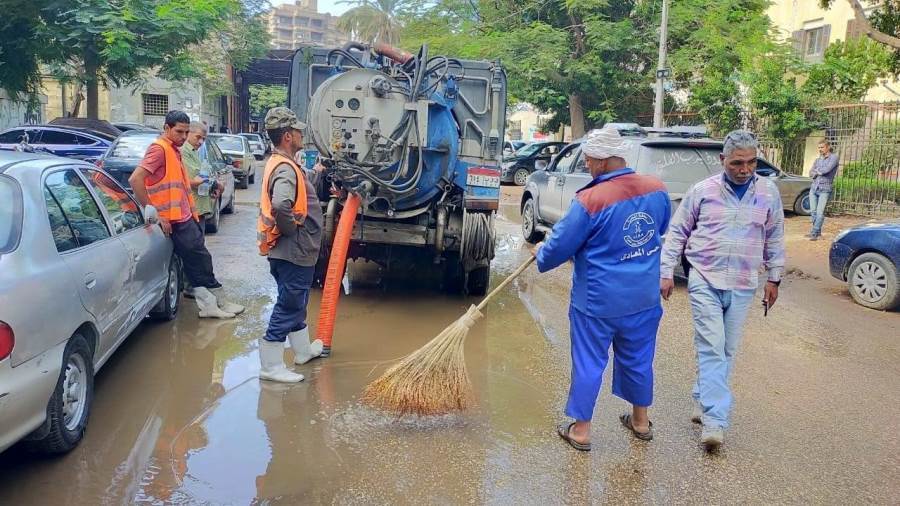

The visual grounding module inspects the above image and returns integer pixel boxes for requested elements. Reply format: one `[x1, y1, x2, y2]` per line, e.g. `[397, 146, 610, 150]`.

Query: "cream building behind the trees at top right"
[766, 0, 900, 102]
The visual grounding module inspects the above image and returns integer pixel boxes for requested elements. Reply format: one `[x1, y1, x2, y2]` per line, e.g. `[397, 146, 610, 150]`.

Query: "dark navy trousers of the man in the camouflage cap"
[266, 258, 316, 343]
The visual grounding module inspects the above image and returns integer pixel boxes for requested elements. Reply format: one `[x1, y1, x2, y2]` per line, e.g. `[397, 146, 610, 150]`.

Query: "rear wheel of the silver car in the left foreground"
[27, 334, 94, 453]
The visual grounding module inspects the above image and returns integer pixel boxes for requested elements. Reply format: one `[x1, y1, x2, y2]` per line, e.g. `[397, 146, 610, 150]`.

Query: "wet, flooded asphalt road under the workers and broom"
[0, 180, 900, 504]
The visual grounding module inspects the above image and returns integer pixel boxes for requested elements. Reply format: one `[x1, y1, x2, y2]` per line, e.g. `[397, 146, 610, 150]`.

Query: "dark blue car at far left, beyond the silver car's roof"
[0, 125, 116, 162]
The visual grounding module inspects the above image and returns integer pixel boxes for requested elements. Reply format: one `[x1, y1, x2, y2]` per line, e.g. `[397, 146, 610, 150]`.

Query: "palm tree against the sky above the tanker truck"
[337, 0, 416, 46]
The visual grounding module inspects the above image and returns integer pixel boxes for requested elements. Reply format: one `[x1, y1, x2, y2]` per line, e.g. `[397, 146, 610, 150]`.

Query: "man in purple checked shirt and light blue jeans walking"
[660, 130, 784, 451]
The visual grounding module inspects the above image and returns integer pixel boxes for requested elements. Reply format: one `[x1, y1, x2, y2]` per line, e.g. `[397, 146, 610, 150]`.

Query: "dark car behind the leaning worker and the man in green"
[97, 130, 234, 234]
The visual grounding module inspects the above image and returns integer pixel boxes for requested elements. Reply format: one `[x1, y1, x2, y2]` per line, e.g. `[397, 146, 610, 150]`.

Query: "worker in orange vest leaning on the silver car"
[128, 111, 244, 318]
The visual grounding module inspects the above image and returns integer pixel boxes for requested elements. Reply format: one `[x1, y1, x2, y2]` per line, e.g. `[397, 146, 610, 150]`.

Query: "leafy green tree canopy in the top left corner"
[0, 0, 268, 118]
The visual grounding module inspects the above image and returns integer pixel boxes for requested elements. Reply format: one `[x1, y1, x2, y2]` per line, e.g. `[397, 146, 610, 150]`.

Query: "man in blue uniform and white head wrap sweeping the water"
[532, 129, 670, 451]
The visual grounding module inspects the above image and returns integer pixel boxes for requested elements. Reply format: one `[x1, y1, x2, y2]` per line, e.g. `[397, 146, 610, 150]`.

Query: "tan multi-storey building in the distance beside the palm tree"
[269, 0, 350, 49]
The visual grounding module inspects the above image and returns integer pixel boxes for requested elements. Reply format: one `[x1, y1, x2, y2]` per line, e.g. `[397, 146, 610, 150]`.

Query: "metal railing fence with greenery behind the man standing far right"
[652, 102, 900, 217]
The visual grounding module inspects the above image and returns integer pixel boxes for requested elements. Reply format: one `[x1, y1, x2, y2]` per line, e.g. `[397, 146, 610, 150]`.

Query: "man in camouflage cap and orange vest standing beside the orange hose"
[257, 107, 323, 383]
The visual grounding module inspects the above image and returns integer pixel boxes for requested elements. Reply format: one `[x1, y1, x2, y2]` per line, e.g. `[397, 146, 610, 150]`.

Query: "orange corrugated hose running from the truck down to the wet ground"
[316, 193, 360, 357]
